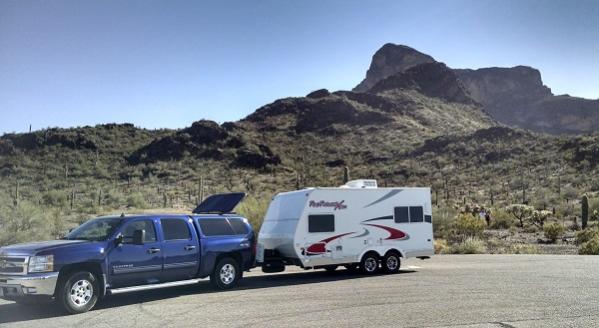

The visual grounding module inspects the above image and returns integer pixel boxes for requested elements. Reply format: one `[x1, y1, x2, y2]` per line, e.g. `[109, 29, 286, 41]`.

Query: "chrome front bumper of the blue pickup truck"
[0, 272, 58, 299]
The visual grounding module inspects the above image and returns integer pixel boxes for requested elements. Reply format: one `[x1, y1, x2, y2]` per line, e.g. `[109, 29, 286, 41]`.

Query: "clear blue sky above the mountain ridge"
[0, 0, 599, 133]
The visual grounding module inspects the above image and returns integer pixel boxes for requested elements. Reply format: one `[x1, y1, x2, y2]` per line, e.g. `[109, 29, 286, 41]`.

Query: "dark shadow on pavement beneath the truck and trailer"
[0, 270, 415, 324]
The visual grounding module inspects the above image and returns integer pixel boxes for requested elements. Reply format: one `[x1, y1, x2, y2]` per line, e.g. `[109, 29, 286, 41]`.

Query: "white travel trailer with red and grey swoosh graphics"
[256, 180, 434, 273]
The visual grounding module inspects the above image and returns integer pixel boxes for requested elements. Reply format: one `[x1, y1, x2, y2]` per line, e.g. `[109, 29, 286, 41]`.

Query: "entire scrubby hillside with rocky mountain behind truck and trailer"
[0, 44, 599, 244]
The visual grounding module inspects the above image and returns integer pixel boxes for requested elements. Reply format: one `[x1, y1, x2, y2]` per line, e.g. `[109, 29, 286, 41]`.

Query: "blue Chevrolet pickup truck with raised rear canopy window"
[0, 193, 256, 314]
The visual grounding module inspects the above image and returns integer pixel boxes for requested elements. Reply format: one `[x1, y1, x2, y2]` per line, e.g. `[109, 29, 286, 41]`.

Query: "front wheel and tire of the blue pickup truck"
[56, 271, 100, 314]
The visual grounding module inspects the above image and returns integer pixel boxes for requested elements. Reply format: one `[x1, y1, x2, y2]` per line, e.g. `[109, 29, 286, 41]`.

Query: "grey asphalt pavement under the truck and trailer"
[0, 255, 599, 328]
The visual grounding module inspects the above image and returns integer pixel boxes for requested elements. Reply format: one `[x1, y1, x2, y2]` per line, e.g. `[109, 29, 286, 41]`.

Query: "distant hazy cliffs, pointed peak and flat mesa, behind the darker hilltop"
[354, 44, 599, 134]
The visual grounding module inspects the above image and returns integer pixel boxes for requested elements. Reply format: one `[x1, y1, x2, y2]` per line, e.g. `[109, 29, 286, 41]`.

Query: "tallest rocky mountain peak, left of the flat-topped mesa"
[353, 43, 435, 92]
